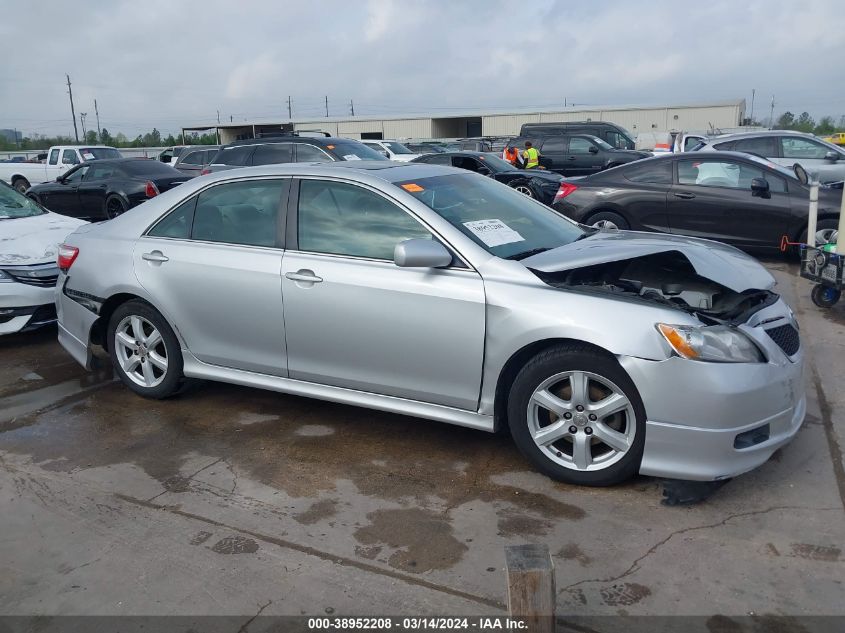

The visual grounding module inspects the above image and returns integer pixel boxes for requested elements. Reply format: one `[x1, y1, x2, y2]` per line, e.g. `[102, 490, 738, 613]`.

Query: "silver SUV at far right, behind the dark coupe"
[698, 130, 845, 183]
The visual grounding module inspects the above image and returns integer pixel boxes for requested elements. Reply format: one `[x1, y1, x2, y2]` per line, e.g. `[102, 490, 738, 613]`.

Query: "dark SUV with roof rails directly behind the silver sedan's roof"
[203, 135, 387, 174]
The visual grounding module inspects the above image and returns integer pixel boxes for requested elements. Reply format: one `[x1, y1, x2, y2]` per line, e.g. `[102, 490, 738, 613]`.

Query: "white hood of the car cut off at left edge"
[0, 213, 87, 266]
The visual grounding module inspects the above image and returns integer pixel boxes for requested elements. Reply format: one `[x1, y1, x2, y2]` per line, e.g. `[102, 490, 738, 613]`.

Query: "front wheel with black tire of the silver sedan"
[508, 343, 645, 486]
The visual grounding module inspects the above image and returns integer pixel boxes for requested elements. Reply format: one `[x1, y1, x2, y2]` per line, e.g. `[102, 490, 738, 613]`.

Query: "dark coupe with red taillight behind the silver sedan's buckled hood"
[553, 152, 842, 249]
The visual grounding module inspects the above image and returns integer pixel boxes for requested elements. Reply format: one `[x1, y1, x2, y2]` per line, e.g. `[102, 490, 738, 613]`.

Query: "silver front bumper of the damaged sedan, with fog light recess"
[620, 301, 807, 481]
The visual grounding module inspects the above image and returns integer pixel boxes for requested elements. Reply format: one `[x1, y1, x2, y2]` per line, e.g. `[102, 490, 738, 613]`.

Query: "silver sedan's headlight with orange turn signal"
[657, 323, 765, 363]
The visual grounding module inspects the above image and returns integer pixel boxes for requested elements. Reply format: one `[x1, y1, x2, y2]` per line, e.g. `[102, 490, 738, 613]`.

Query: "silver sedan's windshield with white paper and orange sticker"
[395, 174, 585, 259]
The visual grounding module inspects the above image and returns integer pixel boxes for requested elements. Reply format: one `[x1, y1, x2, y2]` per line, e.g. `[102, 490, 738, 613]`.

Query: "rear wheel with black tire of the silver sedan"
[108, 300, 184, 400]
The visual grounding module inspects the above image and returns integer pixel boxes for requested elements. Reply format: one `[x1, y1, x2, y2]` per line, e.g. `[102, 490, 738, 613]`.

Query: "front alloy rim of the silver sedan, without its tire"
[528, 371, 637, 471]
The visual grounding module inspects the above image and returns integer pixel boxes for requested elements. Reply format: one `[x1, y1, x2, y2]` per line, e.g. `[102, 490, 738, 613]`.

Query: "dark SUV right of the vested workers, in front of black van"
[508, 134, 651, 176]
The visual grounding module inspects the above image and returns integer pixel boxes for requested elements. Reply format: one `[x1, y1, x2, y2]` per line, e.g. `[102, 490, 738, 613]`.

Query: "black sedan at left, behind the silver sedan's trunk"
[26, 158, 189, 221]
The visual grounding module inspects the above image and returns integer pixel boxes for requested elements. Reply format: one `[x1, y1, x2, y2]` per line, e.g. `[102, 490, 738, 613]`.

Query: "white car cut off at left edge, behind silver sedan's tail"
[0, 183, 87, 335]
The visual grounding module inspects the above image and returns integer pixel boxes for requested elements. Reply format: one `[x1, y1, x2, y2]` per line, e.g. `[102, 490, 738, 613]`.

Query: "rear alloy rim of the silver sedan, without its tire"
[114, 315, 167, 387]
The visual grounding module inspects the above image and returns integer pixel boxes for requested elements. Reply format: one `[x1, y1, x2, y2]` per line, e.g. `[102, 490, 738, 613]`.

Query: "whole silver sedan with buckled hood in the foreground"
[57, 161, 805, 485]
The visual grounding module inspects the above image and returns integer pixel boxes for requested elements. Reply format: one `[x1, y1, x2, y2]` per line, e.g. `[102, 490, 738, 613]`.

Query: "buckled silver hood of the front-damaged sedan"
[520, 231, 775, 292]
